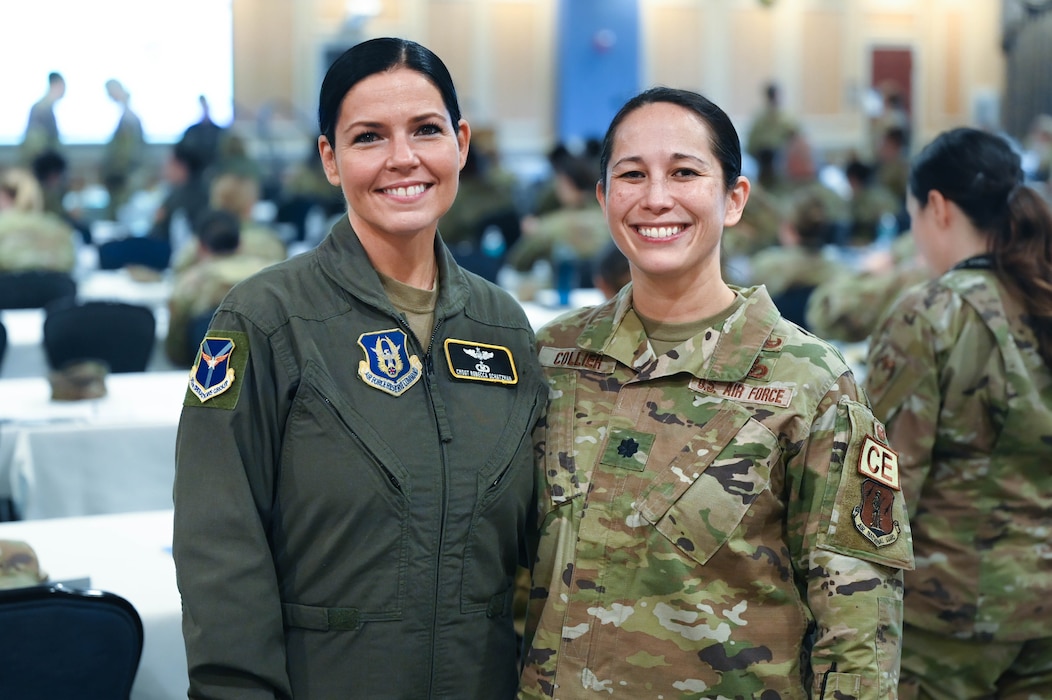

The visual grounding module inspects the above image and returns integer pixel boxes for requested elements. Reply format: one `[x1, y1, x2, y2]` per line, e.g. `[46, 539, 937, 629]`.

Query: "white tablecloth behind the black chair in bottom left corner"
[0, 509, 188, 700]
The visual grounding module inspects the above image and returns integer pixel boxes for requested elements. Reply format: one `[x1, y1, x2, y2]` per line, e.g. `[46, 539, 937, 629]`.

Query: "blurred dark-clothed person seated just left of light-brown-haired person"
[148, 140, 208, 251]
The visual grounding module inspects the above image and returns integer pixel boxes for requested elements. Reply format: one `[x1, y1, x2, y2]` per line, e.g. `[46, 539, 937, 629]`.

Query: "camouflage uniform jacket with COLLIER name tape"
[520, 285, 912, 700]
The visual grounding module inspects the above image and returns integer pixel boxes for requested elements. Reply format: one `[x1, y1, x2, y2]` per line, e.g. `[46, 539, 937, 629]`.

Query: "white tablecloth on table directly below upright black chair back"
[0, 371, 187, 519]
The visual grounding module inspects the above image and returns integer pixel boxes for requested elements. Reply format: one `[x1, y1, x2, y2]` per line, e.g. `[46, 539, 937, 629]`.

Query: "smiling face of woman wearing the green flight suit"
[318, 67, 470, 249]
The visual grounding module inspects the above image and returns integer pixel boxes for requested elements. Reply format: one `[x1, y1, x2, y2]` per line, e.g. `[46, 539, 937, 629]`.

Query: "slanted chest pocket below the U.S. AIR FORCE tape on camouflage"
[640, 403, 778, 564]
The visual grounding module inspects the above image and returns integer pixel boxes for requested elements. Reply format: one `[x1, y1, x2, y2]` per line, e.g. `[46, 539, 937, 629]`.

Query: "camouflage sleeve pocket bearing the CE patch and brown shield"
[818, 399, 913, 568]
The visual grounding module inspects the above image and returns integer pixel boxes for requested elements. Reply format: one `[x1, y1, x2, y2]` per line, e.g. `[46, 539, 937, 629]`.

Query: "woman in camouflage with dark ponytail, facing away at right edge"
[866, 128, 1052, 700]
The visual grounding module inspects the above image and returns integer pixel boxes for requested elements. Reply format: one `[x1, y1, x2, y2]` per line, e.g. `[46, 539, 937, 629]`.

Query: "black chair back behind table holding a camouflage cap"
[44, 301, 157, 373]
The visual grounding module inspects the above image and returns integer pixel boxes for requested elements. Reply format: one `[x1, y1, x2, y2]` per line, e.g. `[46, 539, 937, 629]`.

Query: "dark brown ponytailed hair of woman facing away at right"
[909, 127, 1052, 368]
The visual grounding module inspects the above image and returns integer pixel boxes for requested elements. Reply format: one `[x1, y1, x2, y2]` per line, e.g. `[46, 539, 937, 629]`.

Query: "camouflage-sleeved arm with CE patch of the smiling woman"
[788, 374, 913, 700]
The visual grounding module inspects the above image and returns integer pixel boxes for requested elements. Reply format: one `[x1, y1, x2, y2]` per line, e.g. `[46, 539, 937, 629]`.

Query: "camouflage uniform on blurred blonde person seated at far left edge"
[0, 209, 77, 273]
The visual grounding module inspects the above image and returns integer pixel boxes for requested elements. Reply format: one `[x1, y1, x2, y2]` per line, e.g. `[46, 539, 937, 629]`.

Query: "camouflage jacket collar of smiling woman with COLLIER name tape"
[578, 284, 781, 382]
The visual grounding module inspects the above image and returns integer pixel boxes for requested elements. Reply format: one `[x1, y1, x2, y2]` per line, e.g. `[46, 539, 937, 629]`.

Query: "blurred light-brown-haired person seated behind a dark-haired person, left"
[171, 171, 288, 272]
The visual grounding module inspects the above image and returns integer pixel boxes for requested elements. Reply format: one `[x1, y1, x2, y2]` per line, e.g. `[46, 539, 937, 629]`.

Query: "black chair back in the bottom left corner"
[0, 585, 143, 700]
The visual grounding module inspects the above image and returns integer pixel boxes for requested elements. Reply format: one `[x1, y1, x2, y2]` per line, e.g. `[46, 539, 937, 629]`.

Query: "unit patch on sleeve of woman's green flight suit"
[183, 328, 248, 411]
